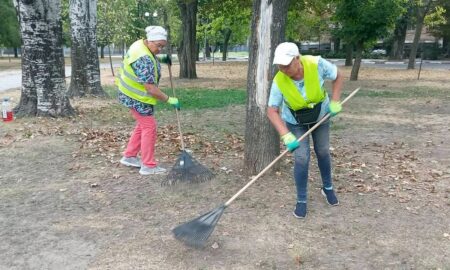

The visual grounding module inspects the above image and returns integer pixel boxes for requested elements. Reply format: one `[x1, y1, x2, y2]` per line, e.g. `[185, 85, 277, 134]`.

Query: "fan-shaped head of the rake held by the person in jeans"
[172, 205, 226, 248]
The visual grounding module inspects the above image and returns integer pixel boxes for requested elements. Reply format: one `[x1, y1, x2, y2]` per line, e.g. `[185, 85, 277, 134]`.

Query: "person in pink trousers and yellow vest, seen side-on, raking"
[117, 26, 180, 175]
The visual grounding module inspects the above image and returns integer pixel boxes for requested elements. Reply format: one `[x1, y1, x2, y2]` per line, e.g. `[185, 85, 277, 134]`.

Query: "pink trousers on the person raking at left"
[123, 109, 158, 167]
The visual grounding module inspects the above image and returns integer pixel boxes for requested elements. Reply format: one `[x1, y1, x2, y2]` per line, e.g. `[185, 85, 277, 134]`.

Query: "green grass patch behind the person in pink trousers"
[104, 86, 246, 110]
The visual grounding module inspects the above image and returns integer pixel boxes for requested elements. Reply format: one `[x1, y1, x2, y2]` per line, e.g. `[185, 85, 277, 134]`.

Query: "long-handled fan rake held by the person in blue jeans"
[172, 88, 360, 248]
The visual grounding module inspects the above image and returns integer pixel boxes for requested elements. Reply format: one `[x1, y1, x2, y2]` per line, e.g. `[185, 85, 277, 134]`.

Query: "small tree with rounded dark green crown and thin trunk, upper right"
[335, 0, 404, 81]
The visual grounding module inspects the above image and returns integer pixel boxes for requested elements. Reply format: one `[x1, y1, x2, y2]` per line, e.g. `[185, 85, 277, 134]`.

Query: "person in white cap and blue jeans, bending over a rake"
[267, 42, 343, 218]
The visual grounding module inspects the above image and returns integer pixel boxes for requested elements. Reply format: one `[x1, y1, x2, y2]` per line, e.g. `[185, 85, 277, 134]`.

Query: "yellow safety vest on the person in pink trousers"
[116, 39, 159, 105]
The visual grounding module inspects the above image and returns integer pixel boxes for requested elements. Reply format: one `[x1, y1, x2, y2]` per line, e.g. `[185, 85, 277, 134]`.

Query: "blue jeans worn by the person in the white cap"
[286, 121, 333, 202]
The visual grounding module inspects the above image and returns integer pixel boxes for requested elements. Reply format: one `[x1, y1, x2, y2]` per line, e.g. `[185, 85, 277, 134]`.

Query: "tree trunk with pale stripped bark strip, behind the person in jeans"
[244, 0, 289, 175]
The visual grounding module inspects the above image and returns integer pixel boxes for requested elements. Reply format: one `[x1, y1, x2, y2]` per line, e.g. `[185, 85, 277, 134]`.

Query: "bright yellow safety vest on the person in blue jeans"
[274, 55, 326, 111]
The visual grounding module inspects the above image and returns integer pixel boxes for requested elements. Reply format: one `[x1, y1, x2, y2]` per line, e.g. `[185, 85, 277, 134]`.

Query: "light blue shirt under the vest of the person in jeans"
[268, 56, 337, 125]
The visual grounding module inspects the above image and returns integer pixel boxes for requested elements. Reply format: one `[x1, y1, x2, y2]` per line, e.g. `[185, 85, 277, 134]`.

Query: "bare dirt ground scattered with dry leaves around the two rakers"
[0, 63, 450, 269]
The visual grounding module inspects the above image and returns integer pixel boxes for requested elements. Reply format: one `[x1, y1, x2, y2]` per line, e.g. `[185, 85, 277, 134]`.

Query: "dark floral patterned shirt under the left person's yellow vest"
[118, 55, 161, 116]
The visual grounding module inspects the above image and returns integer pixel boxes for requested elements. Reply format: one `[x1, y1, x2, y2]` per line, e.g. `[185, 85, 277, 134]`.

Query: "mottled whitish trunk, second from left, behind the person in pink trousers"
[68, 0, 105, 97]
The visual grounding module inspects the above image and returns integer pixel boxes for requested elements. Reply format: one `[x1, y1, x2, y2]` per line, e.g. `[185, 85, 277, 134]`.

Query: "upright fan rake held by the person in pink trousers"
[162, 65, 214, 185]
